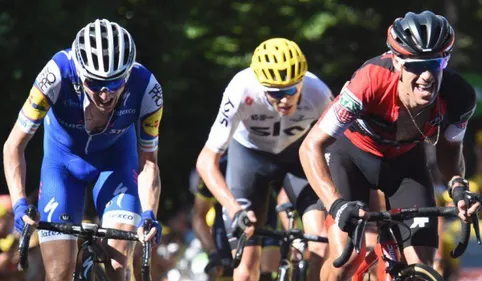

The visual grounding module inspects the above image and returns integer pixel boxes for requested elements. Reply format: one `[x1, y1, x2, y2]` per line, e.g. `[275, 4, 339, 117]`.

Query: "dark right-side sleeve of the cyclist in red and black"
[440, 70, 477, 142]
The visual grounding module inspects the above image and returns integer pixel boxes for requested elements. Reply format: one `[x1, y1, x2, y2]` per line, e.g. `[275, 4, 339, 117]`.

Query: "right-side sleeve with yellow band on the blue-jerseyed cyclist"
[137, 74, 163, 152]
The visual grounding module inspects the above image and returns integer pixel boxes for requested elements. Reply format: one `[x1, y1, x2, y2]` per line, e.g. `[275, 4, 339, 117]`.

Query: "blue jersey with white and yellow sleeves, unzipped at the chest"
[17, 49, 163, 155]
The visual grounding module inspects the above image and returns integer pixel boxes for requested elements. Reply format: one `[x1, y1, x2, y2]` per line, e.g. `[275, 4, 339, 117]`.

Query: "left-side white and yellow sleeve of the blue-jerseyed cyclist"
[17, 60, 62, 134]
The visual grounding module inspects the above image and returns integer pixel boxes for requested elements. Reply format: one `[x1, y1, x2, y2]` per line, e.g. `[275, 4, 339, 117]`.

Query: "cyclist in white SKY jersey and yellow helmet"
[197, 38, 332, 281]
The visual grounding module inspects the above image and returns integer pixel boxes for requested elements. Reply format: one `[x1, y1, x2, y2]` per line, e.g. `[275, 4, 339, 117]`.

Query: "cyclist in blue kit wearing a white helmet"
[3, 19, 163, 281]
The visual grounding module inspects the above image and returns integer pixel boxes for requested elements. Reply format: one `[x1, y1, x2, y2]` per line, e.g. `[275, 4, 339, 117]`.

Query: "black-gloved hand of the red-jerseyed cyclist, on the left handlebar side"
[329, 198, 368, 233]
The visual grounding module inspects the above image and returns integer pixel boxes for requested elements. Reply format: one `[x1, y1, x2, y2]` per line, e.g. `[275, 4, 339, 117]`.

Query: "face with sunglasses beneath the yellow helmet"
[266, 83, 302, 116]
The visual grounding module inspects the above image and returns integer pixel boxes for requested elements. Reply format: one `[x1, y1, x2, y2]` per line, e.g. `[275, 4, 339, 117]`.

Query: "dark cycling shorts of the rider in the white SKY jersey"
[224, 138, 318, 246]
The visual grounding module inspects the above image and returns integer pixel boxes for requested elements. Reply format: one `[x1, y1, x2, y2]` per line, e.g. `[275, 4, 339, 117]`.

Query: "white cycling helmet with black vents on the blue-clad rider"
[72, 19, 136, 81]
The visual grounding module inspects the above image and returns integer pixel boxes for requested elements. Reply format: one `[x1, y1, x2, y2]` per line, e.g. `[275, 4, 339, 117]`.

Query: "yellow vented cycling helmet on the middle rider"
[251, 38, 308, 88]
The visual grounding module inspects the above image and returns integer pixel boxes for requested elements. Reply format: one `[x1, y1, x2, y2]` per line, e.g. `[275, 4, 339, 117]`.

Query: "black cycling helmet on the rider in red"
[387, 11, 455, 57]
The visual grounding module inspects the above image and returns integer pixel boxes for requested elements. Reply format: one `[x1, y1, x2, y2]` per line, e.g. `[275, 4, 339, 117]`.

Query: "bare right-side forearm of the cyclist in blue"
[138, 161, 161, 214]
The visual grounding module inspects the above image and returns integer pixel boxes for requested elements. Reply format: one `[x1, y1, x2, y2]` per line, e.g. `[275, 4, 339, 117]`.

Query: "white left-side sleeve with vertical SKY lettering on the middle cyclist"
[206, 73, 244, 153]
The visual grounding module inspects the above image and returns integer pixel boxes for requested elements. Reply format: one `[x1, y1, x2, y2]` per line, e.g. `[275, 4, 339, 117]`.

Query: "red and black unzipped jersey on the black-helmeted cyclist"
[318, 53, 476, 158]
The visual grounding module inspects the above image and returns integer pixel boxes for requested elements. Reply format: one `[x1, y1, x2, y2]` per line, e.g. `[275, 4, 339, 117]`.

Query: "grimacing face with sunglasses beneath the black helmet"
[398, 55, 448, 106]
